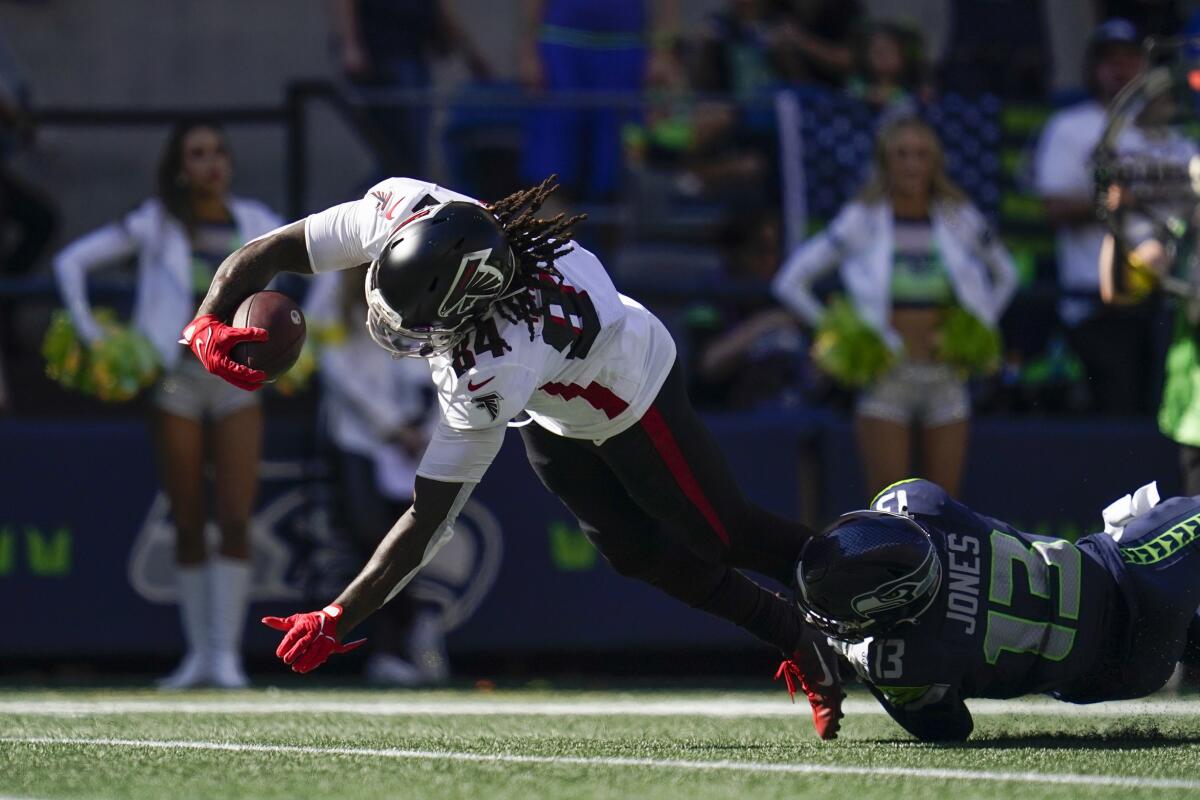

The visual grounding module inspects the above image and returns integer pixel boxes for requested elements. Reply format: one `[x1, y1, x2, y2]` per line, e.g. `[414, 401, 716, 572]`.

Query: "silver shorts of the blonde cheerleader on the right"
[856, 361, 971, 428]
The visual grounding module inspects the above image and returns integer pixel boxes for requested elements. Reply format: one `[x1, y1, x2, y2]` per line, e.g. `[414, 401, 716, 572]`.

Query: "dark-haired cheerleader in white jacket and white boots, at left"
[54, 121, 280, 688]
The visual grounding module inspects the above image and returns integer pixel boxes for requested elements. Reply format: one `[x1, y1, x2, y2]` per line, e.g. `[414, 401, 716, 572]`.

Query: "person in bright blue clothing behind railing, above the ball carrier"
[520, 0, 679, 200]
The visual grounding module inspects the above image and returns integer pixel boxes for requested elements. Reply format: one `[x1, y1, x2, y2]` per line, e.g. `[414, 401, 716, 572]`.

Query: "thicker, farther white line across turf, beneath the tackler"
[0, 693, 1200, 717]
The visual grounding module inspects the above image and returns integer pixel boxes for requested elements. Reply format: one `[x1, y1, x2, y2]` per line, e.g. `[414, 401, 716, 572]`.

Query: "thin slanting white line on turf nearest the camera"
[0, 736, 1200, 790]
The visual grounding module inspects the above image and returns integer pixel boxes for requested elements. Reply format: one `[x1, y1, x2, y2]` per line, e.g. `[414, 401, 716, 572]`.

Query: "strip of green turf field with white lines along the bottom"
[0, 688, 1200, 800]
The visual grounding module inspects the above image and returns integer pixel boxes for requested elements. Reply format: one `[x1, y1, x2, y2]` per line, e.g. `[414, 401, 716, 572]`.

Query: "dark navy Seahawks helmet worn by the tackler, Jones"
[796, 511, 942, 642]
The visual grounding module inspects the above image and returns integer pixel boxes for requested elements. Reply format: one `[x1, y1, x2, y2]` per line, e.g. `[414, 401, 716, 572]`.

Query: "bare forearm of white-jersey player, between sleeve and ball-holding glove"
[196, 219, 312, 320]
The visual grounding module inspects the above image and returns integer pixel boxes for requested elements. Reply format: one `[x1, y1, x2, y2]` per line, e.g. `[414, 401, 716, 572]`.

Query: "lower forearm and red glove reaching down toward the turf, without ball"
[263, 476, 474, 673]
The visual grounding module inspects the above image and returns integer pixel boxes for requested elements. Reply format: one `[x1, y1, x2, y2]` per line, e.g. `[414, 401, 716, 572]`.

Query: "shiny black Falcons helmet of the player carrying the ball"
[366, 200, 516, 357]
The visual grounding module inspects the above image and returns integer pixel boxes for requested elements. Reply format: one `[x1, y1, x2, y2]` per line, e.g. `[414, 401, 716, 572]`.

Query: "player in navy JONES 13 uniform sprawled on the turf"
[796, 480, 1200, 741]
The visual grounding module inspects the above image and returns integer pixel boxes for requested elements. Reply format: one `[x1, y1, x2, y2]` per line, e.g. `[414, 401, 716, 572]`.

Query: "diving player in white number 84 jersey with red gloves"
[185, 178, 842, 739]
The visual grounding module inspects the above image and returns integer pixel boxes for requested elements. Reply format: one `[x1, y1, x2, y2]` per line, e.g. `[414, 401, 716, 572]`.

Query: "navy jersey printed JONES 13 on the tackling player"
[836, 480, 1124, 739]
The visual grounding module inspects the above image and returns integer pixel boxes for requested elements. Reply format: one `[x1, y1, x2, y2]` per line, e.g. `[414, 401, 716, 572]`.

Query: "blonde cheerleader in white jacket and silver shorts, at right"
[774, 116, 1016, 495]
